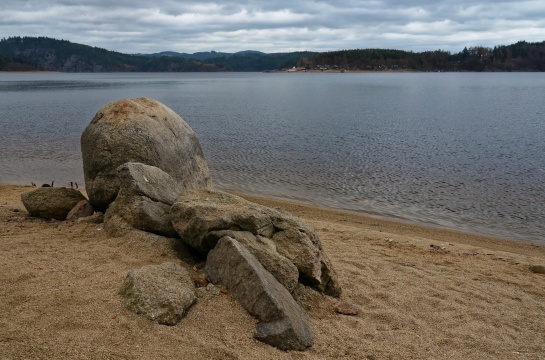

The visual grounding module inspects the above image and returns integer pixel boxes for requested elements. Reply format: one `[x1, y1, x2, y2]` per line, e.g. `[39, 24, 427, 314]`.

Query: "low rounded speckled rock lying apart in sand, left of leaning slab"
[119, 263, 196, 325]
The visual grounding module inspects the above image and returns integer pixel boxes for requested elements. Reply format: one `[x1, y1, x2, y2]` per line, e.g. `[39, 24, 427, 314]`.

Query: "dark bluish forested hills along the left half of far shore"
[0, 37, 317, 72]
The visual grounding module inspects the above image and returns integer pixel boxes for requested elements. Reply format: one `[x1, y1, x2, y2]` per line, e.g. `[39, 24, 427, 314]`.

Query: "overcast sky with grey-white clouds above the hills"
[0, 0, 545, 53]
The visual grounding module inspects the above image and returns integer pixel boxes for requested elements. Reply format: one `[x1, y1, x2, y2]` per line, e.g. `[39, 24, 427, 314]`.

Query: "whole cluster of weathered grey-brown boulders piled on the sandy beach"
[25, 98, 341, 350]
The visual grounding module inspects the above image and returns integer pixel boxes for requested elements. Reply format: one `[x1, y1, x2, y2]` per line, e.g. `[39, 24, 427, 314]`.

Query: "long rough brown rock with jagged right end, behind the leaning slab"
[171, 189, 341, 296]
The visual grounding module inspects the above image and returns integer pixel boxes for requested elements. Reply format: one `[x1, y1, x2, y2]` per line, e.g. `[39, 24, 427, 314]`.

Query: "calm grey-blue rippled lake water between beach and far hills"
[0, 73, 545, 243]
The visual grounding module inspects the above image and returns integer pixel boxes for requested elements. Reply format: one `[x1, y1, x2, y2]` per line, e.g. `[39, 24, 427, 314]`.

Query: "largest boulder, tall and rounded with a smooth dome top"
[81, 98, 211, 211]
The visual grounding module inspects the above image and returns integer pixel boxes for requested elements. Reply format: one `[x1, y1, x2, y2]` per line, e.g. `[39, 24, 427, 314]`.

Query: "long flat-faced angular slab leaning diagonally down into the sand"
[206, 236, 313, 350]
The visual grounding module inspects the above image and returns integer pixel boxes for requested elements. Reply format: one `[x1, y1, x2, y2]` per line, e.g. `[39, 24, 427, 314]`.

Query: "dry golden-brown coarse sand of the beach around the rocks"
[0, 185, 545, 360]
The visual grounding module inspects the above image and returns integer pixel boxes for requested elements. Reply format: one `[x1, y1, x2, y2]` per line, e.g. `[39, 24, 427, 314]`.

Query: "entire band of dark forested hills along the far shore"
[0, 37, 545, 72]
